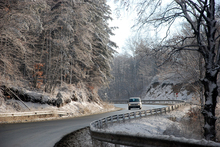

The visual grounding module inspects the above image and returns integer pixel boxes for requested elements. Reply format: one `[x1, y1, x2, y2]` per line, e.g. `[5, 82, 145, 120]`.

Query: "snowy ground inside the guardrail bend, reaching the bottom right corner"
[101, 106, 220, 146]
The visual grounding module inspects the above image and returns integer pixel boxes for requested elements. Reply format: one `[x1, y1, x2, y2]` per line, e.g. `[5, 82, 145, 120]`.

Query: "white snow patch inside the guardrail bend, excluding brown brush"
[105, 106, 190, 136]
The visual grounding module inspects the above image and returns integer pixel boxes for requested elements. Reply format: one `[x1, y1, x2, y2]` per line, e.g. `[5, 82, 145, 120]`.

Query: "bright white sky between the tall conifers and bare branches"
[107, 0, 182, 53]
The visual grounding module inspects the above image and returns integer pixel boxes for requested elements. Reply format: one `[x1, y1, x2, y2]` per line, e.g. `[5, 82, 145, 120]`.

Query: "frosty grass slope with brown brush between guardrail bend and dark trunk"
[105, 106, 202, 139]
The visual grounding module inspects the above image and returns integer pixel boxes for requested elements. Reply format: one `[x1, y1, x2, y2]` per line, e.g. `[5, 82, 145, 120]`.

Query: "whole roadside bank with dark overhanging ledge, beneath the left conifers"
[0, 82, 115, 123]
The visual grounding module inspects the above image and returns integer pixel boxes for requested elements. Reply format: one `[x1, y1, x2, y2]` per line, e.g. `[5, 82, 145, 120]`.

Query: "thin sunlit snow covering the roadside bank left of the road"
[0, 84, 115, 116]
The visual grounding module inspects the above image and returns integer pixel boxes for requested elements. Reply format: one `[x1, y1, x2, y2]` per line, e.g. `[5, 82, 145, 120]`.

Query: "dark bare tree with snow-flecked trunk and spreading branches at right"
[116, 0, 220, 140]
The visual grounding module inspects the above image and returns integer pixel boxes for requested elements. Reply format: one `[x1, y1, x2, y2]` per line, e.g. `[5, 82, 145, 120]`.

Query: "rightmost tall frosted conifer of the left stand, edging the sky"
[85, 0, 116, 89]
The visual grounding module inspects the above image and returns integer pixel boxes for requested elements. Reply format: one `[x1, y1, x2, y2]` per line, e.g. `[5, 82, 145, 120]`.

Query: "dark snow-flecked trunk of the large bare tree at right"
[198, 0, 219, 141]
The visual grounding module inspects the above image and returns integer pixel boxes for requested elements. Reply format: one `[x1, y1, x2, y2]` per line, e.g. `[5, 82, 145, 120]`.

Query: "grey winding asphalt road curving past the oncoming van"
[0, 104, 165, 147]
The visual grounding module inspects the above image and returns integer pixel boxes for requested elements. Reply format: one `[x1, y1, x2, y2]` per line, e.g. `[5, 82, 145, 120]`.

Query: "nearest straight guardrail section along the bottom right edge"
[91, 131, 220, 147]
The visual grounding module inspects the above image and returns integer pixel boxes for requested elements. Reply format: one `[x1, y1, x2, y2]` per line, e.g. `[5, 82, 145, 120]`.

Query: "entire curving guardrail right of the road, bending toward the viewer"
[90, 100, 220, 147]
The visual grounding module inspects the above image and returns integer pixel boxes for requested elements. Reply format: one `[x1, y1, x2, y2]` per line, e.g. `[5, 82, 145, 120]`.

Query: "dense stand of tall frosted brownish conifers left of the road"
[0, 0, 116, 101]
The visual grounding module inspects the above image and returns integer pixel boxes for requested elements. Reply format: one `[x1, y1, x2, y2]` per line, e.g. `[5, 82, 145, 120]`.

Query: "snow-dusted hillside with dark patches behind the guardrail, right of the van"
[142, 73, 200, 104]
